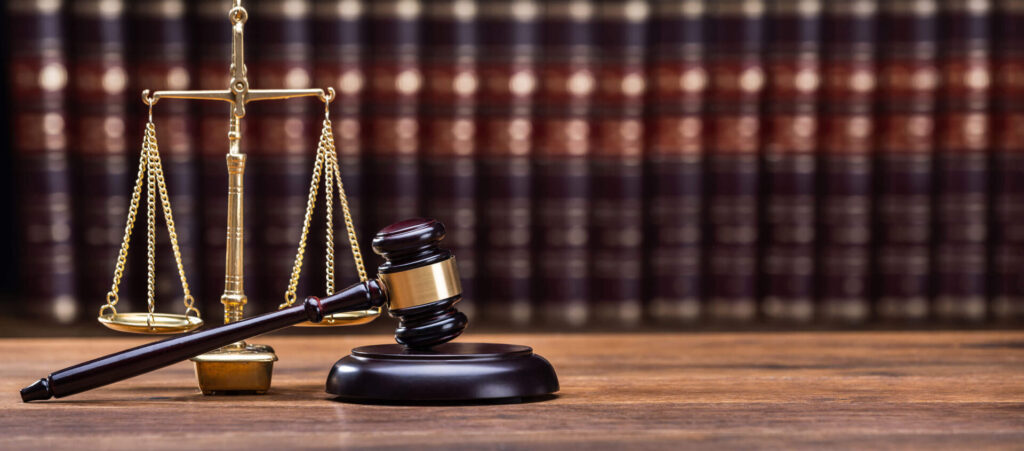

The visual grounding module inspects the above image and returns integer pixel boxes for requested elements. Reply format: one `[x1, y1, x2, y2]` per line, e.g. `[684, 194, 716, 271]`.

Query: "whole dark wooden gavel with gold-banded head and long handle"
[22, 219, 475, 402]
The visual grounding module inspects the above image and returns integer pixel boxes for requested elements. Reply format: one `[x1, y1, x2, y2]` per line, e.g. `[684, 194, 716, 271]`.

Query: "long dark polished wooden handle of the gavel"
[22, 280, 387, 402]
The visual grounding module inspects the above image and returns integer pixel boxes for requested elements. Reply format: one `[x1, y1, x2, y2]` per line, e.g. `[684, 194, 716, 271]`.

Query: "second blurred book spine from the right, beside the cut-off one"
[933, 0, 992, 321]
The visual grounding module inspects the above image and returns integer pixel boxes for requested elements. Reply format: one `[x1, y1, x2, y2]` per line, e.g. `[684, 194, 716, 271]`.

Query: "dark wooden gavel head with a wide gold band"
[373, 218, 468, 349]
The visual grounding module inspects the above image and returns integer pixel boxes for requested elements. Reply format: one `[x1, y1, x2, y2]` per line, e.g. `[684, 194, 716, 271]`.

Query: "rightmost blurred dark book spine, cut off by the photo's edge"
[991, 0, 1024, 322]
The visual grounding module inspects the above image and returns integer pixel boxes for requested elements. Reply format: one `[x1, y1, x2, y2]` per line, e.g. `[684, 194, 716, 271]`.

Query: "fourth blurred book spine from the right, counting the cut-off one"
[817, 0, 880, 323]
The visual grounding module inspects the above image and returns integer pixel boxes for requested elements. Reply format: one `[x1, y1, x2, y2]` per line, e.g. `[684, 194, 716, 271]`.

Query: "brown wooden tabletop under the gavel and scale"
[0, 332, 1024, 450]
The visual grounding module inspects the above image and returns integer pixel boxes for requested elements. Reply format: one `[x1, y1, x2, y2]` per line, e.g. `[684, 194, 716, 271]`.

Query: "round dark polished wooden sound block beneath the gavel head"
[327, 342, 558, 403]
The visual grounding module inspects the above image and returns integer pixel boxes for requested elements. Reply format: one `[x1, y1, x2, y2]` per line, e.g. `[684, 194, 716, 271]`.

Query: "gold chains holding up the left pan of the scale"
[99, 114, 200, 319]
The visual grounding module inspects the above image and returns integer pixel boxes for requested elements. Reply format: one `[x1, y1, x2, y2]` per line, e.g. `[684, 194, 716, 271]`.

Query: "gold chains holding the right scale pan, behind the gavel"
[279, 112, 369, 309]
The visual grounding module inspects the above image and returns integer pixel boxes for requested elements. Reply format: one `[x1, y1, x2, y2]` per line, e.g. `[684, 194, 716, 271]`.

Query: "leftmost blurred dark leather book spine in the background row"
[3, 0, 78, 324]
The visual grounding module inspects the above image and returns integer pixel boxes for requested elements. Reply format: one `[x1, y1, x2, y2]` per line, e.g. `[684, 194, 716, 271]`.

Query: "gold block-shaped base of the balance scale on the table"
[191, 341, 278, 395]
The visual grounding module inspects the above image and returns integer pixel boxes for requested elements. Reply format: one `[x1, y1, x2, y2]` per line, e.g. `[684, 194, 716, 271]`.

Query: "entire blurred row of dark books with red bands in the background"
[6, 0, 1024, 327]
